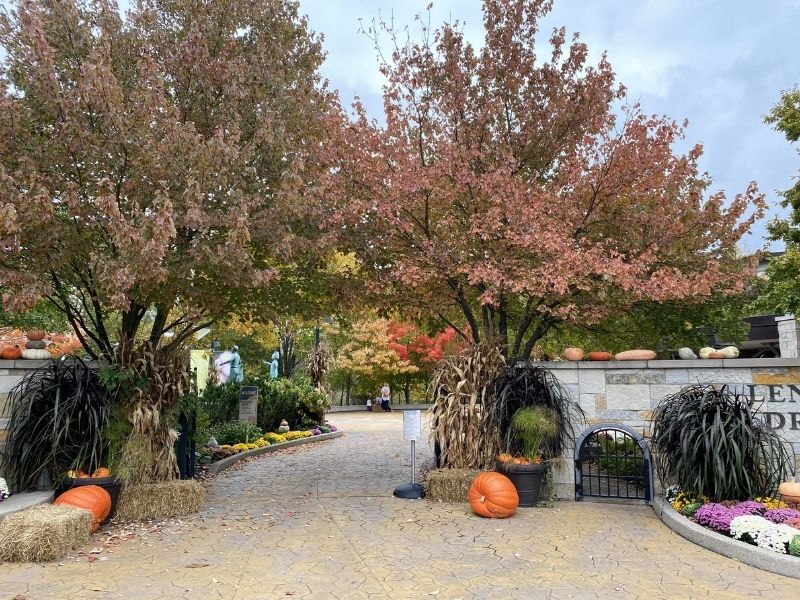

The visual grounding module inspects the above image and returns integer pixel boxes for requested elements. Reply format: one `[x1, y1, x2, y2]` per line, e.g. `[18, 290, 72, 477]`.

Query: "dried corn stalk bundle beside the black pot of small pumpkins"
[429, 345, 505, 469]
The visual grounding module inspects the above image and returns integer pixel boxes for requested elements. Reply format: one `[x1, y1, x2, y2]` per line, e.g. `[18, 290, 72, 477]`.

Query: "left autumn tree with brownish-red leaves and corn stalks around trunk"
[0, 0, 329, 481]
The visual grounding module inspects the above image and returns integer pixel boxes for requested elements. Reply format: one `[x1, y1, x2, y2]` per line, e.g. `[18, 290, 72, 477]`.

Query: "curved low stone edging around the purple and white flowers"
[653, 496, 800, 579]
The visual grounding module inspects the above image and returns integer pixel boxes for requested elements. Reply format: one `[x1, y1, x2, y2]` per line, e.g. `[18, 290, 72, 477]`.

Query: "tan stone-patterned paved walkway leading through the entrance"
[0, 412, 800, 600]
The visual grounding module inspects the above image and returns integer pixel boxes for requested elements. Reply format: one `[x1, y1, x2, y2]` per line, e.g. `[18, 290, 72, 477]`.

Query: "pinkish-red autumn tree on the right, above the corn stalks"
[327, 0, 764, 359]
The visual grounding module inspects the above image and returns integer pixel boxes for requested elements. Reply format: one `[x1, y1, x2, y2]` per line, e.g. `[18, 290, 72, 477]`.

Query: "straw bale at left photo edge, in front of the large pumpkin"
[0, 504, 92, 562]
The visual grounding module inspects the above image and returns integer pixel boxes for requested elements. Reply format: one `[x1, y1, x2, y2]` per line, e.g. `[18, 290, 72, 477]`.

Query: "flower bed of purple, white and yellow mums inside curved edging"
[665, 487, 800, 557]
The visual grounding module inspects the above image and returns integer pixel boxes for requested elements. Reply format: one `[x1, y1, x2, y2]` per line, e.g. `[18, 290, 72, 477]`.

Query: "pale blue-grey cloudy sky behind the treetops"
[300, 0, 800, 250]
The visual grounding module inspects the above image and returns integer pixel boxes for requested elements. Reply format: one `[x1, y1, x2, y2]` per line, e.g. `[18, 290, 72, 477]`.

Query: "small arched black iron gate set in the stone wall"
[575, 423, 653, 502]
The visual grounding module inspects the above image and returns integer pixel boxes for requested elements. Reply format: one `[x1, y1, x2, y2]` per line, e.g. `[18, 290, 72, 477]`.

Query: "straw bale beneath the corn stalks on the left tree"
[116, 480, 206, 521]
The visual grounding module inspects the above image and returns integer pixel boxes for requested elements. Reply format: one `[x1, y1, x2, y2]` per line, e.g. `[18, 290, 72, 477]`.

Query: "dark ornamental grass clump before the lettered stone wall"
[651, 386, 794, 500]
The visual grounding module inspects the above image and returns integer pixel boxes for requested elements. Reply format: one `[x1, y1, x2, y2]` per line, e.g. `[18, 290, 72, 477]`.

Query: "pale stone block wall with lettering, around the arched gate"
[535, 358, 800, 498]
